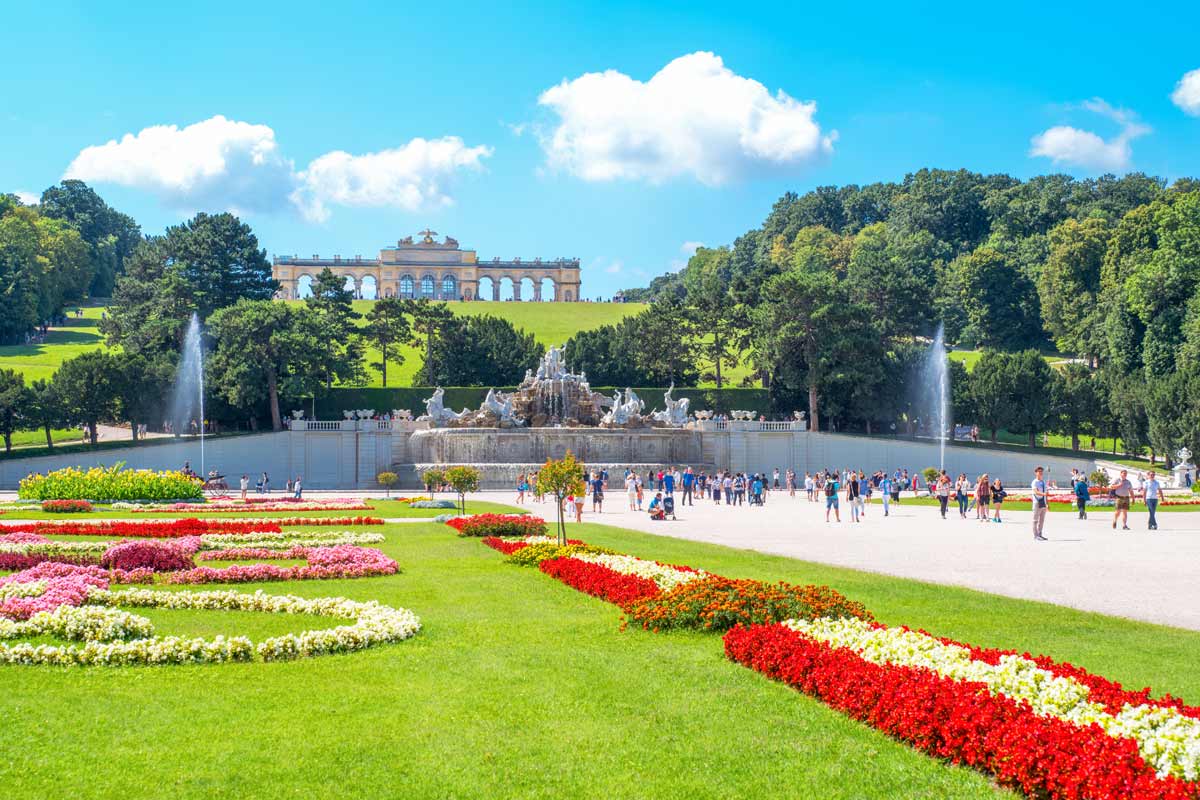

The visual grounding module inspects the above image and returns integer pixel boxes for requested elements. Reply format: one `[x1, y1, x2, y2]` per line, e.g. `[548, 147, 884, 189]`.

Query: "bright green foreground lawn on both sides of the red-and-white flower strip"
[0, 515, 1200, 799]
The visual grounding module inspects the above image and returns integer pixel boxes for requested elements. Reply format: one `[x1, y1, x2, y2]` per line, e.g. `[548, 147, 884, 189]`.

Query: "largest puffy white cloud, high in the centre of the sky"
[538, 53, 836, 186]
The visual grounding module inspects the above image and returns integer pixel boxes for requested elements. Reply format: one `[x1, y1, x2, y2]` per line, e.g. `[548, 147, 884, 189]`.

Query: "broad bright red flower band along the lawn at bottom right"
[725, 625, 1200, 800]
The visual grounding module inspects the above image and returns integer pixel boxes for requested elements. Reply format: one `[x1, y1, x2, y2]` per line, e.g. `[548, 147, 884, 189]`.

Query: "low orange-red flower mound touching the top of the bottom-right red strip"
[625, 575, 874, 631]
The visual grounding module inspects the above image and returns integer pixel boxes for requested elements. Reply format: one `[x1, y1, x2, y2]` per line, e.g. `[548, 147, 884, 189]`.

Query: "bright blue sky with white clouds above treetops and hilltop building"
[0, 0, 1200, 297]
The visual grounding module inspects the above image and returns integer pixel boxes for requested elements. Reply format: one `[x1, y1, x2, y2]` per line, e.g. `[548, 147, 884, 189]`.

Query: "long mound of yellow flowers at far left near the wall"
[17, 463, 204, 503]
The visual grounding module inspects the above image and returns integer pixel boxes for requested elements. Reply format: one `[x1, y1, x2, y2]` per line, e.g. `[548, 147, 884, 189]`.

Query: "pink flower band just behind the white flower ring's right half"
[163, 545, 400, 583]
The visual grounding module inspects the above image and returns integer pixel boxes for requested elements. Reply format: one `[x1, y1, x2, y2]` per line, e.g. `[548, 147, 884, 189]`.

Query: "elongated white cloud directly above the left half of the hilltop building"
[293, 137, 492, 221]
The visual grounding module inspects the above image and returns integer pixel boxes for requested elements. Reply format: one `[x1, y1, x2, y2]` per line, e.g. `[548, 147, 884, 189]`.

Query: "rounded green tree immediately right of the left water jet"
[208, 300, 295, 431]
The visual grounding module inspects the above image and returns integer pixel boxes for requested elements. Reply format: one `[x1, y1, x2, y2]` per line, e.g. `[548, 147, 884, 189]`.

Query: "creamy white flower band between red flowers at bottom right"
[784, 616, 1200, 781]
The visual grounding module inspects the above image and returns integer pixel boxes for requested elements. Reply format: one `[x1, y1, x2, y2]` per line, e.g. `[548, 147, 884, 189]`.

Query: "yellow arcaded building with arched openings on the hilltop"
[272, 229, 580, 302]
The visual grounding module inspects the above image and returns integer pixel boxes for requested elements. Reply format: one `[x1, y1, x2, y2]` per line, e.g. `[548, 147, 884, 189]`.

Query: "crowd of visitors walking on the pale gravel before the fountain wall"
[516, 467, 1164, 541]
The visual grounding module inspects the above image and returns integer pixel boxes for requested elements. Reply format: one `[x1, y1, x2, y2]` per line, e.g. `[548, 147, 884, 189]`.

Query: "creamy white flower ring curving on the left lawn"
[0, 584, 421, 666]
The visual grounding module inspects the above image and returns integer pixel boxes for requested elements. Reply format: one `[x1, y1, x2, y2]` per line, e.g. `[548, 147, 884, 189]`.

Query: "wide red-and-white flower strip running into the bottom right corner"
[725, 618, 1200, 800]
